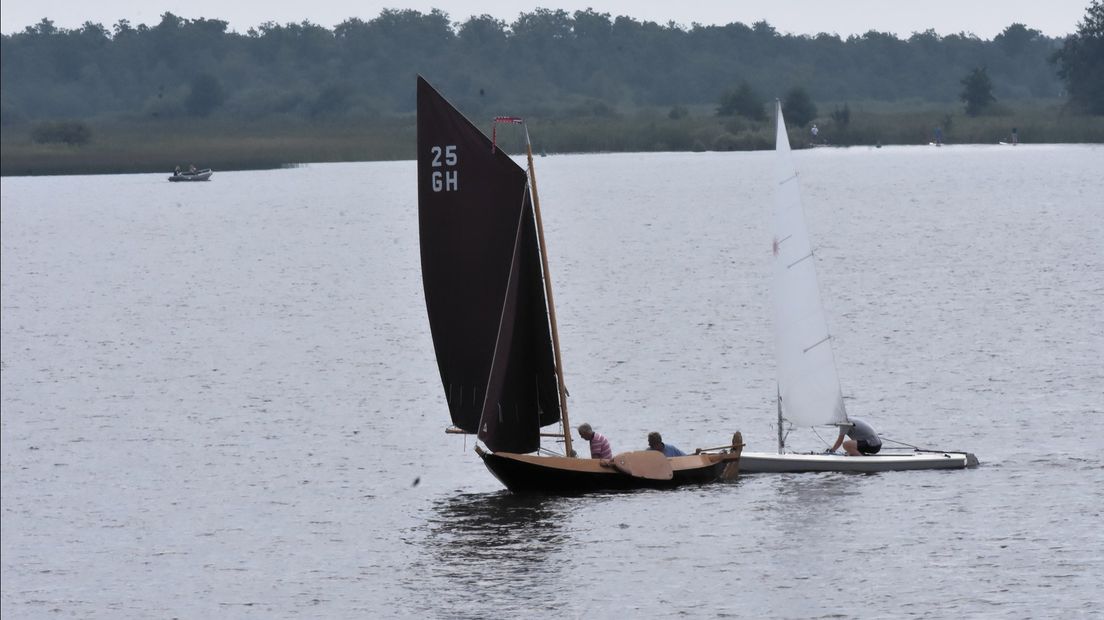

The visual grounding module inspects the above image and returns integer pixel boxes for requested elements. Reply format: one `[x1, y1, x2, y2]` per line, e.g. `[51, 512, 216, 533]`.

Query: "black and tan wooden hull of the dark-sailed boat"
[477, 443, 740, 495]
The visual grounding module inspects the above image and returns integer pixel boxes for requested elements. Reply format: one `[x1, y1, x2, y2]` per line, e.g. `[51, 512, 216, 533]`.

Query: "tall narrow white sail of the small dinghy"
[773, 103, 847, 427]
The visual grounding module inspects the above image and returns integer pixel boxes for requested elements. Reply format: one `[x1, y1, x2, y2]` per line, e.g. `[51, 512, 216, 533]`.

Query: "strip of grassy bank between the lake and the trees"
[0, 103, 1104, 175]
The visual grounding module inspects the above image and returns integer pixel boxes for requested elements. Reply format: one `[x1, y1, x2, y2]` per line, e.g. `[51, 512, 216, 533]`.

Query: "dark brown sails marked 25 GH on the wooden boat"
[417, 77, 560, 452]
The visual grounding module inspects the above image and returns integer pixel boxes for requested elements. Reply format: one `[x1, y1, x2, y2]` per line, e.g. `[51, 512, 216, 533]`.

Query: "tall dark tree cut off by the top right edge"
[1051, 0, 1104, 115]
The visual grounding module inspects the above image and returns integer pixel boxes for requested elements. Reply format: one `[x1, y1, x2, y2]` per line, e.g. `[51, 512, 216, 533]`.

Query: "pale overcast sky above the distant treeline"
[0, 0, 1089, 39]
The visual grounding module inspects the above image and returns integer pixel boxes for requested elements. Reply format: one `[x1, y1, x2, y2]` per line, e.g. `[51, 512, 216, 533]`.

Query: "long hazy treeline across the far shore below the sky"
[0, 9, 1063, 125]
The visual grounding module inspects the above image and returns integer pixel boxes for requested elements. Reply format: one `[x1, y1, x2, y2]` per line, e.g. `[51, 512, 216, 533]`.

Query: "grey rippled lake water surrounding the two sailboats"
[0, 146, 1104, 618]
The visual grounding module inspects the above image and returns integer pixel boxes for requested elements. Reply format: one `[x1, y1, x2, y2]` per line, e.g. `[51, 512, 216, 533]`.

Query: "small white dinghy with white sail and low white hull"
[741, 103, 977, 473]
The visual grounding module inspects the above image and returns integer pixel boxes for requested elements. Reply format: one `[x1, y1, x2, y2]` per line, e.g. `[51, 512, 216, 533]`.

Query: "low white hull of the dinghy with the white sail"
[740, 451, 977, 473]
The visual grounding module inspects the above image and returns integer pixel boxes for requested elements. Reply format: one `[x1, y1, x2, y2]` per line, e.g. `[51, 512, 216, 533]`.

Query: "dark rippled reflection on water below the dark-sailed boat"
[422, 491, 570, 613]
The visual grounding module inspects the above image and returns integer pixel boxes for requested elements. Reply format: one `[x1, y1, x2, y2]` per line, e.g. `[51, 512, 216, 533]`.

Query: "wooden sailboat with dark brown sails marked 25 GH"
[417, 76, 743, 493]
